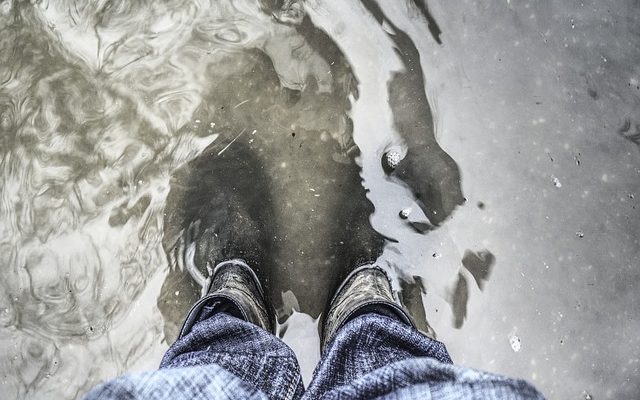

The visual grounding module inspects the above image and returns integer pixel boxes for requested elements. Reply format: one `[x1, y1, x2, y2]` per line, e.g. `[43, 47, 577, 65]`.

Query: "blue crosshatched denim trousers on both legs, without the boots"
[85, 313, 544, 400]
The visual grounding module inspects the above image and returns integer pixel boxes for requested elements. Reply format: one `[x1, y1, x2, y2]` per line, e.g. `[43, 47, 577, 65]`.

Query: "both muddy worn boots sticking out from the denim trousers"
[179, 259, 415, 352]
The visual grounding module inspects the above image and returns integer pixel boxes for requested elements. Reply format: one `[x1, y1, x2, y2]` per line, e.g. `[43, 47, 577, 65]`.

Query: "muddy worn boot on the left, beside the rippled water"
[178, 259, 275, 338]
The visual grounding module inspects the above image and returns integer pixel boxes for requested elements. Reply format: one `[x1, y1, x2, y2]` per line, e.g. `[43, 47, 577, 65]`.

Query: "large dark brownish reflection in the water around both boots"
[158, 43, 384, 338]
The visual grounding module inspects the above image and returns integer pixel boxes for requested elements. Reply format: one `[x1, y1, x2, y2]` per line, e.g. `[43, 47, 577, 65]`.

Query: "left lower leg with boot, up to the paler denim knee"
[160, 260, 303, 399]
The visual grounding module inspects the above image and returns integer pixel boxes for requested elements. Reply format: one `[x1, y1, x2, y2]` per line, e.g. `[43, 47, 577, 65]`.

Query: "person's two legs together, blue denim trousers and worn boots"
[86, 238, 542, 399]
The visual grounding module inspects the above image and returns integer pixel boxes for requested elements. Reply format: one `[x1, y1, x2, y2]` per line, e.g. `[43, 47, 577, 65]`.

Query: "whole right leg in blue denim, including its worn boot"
[305, 268, 542, 399]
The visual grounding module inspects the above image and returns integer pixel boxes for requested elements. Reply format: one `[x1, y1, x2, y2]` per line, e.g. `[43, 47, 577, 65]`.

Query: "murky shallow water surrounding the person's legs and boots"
[0, 0, 640, 398]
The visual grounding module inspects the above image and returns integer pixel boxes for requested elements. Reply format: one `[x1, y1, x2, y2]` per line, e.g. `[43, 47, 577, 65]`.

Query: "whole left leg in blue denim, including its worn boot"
[87, 260, 304, 400]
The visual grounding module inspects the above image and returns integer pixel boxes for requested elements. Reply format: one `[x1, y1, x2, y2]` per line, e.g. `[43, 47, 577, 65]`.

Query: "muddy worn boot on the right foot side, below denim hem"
[320, 265, 415, 354]
